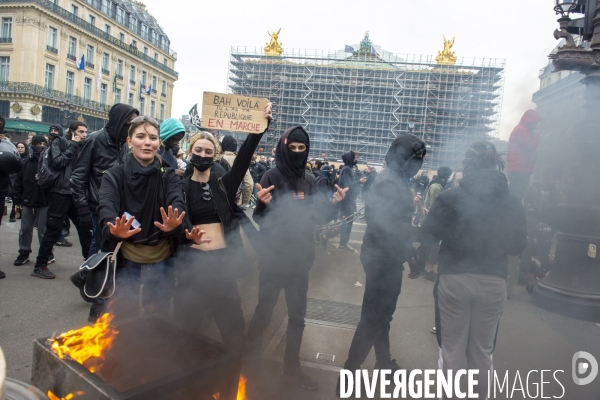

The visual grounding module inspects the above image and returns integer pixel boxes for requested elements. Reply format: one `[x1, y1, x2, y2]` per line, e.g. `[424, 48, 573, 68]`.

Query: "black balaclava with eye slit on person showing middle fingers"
[275, 126, 310, 178]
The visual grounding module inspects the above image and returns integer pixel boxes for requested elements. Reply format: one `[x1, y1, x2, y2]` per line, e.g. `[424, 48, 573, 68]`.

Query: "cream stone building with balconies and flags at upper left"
[0, 0, 178, 136]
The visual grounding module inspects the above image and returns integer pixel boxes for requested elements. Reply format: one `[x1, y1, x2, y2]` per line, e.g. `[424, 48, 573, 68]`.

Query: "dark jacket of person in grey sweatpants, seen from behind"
[421, 169, 527, 278]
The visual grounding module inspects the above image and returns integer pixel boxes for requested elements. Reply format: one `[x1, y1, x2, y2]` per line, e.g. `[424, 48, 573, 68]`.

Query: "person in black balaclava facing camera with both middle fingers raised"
[248, 126, 347, 389]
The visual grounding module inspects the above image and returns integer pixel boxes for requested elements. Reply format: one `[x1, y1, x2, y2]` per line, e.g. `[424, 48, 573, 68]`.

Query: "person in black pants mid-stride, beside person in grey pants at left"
[32, 121, 92, 279]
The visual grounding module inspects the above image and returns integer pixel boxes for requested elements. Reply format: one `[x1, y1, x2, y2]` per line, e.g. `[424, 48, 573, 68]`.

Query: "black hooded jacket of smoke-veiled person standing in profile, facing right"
[360, 135, 425, 268]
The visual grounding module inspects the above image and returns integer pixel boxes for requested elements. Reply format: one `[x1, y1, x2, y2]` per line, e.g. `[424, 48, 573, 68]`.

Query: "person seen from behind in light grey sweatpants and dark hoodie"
[421, 142, 527, 399]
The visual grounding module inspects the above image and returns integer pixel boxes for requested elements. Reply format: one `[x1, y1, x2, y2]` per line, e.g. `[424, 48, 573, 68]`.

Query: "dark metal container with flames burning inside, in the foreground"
[31, 314, 240, 400]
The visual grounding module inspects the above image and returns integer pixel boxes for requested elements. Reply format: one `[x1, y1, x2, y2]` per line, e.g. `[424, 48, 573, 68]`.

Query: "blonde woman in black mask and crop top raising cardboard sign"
[175, 103, 272, 357]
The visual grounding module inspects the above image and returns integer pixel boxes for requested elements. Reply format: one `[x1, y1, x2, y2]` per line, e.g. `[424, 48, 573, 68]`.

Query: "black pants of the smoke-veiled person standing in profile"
[344, 260, 404, 370]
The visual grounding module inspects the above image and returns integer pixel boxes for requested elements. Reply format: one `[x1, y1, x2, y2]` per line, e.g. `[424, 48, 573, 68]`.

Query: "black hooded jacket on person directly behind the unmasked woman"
[71, 104, 139, 214]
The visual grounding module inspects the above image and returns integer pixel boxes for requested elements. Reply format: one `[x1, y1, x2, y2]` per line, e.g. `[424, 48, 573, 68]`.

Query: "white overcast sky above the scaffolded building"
[143, 0, 558, 139]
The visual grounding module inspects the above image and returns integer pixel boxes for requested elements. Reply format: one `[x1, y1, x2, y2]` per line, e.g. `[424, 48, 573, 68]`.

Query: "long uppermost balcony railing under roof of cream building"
[0, 0, 179, 78]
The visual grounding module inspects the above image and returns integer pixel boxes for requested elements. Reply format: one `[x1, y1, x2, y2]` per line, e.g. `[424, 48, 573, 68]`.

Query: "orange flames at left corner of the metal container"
[50, 313, 119, 374]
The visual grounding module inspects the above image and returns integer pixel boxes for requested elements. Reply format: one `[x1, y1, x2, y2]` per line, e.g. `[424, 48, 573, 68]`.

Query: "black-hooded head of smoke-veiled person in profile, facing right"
[385, 135, 426, 179]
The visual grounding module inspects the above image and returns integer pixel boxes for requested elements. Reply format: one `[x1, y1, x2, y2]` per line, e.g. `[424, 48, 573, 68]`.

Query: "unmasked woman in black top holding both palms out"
[97, 116, 191, 319]
